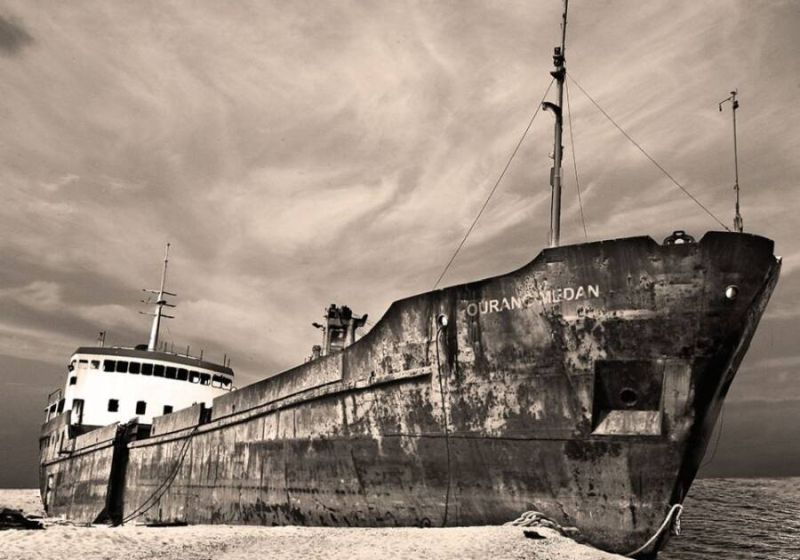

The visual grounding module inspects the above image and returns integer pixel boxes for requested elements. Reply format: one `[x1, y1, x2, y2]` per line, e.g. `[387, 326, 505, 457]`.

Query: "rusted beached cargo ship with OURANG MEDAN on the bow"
[39, 3, 781, 558]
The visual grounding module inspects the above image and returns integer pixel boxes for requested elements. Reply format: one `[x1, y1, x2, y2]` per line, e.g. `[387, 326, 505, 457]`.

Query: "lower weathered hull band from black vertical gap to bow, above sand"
[125, 435, 679, 550]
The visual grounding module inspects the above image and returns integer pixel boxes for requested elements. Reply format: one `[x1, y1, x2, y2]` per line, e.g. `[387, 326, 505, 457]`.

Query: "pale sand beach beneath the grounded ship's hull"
[0, 490, 622, 560]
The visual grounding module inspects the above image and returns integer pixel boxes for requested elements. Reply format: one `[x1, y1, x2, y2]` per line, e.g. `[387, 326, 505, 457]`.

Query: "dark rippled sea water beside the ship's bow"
[659, 478, 800, 560]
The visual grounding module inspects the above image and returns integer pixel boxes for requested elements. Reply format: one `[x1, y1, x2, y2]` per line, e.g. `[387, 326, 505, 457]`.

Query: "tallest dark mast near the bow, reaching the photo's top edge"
[542, 0, 569, 247]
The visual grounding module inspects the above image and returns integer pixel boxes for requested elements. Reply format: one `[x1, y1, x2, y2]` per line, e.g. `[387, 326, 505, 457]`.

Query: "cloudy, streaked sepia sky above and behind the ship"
[0, 0, 800, 485]
